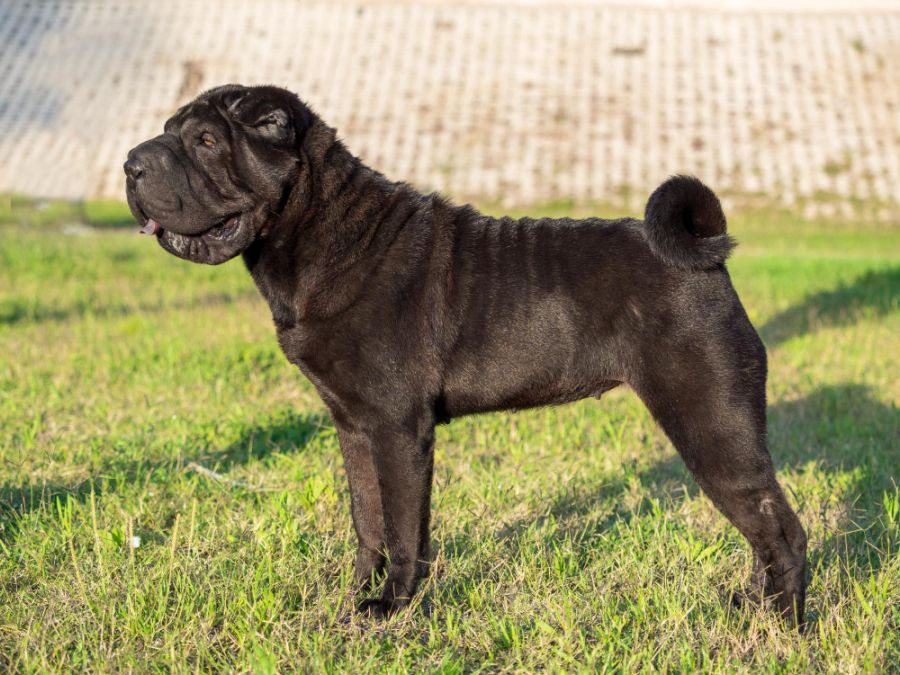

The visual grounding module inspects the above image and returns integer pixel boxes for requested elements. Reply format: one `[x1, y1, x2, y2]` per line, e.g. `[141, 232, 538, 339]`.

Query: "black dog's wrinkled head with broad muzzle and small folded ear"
[125, 85, 313, 265]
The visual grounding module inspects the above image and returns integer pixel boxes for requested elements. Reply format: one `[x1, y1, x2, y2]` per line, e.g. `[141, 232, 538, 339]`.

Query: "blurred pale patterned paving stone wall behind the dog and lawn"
[0, 0, 900, 221]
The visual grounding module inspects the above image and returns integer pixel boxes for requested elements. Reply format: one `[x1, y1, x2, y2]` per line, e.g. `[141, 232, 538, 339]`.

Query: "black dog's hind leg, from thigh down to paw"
[632, 336, 806, 624]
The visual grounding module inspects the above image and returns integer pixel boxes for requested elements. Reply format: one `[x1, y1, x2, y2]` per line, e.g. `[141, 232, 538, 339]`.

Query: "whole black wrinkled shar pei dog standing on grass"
[125, 85, 806, 623]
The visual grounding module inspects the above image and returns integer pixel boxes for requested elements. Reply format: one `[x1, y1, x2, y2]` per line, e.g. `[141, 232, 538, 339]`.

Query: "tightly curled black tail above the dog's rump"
[644, 176, 735, 270]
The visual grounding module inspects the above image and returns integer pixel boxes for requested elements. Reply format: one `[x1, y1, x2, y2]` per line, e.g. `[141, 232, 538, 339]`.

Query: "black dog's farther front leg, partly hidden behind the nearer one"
[336, 424, 384, 589]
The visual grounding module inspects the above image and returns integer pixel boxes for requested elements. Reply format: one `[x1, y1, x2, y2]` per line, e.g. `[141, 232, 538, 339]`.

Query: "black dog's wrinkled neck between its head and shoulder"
[245, 121, 427, 327]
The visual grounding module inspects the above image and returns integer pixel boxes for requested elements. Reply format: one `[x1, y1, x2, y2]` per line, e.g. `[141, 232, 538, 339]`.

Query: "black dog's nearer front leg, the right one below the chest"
[360, 423, 434, 616]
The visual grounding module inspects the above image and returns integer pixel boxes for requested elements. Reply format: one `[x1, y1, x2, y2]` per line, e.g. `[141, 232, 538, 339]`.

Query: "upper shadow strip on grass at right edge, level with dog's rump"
[759, 266, 900, 347]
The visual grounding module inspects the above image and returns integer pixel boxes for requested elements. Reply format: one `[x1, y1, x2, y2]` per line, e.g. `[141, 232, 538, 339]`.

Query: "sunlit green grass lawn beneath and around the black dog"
[0, 206, 900, 673]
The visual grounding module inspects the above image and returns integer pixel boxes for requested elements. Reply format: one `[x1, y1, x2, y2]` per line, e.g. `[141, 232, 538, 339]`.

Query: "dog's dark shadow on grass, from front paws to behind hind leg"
[426, 384, 900, 605]
